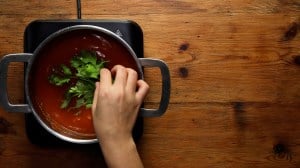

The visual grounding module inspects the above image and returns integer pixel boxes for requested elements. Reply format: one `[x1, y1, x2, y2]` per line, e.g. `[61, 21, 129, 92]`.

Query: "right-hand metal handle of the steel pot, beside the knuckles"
[139, 58, 170, 117]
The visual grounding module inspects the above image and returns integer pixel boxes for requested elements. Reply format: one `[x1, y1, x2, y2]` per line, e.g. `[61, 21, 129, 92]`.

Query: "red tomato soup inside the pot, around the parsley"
[28, 30, 138, 138]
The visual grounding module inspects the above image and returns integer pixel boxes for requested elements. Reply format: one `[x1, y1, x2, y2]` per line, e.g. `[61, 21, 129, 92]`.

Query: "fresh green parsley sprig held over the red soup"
[49, 50, 106, 108]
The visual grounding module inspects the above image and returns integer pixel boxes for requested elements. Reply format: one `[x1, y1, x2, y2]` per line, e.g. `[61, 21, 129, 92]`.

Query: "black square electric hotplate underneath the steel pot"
[24, 20, 144, 145]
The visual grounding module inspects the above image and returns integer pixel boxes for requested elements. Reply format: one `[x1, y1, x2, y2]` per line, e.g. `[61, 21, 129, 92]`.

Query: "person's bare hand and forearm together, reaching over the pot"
[92, 65, 149, 168]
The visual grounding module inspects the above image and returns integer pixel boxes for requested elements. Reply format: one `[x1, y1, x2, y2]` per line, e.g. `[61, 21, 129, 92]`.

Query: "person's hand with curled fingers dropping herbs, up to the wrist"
[92, 65, 149, 143]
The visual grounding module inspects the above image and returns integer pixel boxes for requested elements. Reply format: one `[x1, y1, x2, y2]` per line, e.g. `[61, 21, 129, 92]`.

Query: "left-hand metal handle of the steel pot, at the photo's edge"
[0, 53, 32, 113]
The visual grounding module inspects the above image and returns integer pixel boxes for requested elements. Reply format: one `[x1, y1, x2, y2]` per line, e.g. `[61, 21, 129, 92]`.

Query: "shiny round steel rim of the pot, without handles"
[25, 25, 144, 144]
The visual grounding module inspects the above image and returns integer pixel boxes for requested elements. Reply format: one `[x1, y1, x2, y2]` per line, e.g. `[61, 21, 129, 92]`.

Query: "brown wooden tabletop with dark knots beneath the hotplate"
[0, 0, 300, 168]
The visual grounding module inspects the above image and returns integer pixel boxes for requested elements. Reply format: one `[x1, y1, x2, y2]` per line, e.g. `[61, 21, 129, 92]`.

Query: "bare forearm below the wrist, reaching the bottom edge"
[100, 138, 143, 168]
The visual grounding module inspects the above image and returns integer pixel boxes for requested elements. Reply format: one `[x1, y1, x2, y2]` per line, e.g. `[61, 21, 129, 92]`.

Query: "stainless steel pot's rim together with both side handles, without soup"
[0, 25, 170, 144]
